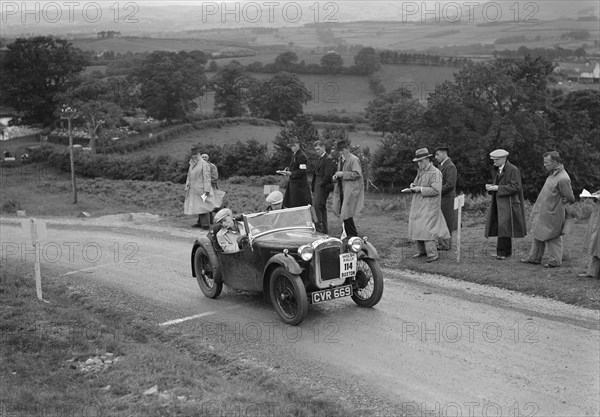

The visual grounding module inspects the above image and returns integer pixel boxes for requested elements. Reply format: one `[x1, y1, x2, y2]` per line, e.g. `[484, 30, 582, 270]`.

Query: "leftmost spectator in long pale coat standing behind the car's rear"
[183, 152, 225, 229]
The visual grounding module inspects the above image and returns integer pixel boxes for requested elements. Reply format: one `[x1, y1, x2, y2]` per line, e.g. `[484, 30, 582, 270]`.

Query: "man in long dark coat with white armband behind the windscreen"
[282, 137, 312, 208]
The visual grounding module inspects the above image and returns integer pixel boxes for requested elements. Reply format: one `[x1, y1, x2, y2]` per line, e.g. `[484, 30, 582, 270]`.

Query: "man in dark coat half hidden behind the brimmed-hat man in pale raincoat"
[433, 145, 457, 250]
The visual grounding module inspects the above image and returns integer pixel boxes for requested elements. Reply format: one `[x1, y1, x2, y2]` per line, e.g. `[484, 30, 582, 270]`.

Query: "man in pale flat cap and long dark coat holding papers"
[485, 149, 527, 260]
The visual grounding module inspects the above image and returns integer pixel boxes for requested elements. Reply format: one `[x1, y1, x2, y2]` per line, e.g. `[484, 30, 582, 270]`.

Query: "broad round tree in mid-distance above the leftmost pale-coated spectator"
[133, 51, 206, 122]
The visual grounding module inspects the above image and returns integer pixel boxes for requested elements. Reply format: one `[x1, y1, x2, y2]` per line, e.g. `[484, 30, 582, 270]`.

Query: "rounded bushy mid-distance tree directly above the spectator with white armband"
[248, 72, 312, 121]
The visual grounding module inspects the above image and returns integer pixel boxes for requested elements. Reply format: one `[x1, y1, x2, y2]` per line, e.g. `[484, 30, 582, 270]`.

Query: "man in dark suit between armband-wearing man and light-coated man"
[310, 141, 335, 234]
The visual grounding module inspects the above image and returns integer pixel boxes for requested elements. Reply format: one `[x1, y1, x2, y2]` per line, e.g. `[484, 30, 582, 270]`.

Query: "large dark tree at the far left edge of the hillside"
[2, 36, 86, 123]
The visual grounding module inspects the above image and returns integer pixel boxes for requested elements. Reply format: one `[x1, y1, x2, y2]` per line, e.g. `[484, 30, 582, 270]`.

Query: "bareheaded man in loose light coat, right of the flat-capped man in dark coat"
[521, 151, 575, 268]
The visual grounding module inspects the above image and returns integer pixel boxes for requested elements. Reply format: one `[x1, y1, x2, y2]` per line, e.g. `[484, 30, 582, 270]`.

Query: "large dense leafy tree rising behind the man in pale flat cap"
[422, 56, 556, 199]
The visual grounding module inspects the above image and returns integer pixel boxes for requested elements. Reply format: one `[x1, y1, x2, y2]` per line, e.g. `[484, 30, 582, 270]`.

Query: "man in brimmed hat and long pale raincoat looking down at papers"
[408, 148, 450, 262]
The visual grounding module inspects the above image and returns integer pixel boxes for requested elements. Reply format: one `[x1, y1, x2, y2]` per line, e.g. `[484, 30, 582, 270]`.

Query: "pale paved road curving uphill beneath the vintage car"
[0, 219, 600, 416]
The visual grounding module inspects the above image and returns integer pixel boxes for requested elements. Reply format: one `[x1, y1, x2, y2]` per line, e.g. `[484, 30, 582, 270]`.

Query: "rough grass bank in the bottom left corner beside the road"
[0, 263, 364, 417]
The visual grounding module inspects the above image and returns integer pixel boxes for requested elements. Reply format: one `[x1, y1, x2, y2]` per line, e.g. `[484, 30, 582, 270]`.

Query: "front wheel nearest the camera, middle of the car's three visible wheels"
[269, 266, 308, 326]
